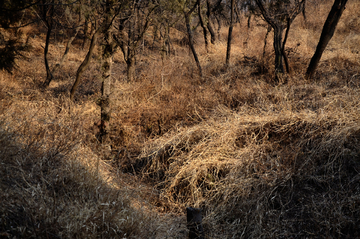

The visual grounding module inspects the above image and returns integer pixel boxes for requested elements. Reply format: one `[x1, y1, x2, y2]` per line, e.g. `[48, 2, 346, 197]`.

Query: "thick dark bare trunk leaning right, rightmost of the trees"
[305, 0, 347, 79]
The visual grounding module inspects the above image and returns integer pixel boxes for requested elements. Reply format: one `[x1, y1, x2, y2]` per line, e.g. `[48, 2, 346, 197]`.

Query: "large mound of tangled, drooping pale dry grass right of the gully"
[139, 106, 360, 238]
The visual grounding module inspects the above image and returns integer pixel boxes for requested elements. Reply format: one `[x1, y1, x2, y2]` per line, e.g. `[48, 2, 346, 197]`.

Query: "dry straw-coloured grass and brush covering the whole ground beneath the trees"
[0, 0, 360, 238]
